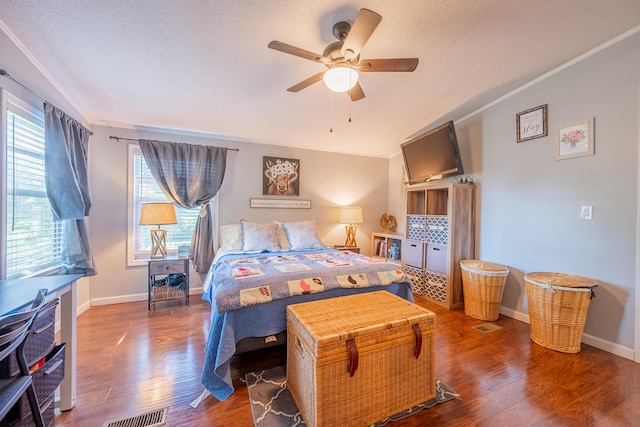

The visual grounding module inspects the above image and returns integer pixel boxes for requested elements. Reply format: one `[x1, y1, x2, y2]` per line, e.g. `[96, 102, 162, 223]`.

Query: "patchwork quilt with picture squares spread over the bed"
[211, 248, 409, 313]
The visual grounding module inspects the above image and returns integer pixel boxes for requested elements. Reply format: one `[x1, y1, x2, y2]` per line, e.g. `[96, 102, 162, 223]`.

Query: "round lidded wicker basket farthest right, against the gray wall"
[524, 272, 597, 353]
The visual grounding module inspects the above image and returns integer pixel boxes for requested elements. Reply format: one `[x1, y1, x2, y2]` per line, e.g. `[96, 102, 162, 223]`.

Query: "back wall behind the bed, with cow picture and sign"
[89, 126, 389, 305]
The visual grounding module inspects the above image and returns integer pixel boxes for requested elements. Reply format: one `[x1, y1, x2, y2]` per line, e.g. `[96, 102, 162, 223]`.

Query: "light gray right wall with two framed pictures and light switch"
[450, 30, 640, 358]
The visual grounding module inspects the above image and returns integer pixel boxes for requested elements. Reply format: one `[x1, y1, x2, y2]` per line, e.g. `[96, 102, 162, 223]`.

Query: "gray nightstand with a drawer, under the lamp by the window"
[147, 257, 189, 311]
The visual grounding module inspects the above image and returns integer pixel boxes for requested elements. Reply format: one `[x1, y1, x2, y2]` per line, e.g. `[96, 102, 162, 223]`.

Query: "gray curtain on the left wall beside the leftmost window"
[44, 102, 96, 276]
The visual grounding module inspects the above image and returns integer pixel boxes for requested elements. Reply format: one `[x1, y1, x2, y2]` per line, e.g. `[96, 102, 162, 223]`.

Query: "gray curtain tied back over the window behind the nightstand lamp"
[140, 139, 227, 272]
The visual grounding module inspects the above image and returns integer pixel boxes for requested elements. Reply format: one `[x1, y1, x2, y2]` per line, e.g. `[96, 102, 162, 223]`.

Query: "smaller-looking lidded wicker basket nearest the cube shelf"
[460, 260, 509, 320]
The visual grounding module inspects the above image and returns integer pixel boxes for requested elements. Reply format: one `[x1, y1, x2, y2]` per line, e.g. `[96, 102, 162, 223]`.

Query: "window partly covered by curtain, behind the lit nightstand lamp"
[128, 144, 200, 265]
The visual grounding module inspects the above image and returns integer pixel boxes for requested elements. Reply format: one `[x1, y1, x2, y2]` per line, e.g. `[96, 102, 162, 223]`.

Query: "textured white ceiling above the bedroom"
[0, 0, 640, 157]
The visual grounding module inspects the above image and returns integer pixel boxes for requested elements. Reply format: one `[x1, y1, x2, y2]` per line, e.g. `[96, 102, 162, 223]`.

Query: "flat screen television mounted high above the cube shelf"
[401, 121, 464, 184]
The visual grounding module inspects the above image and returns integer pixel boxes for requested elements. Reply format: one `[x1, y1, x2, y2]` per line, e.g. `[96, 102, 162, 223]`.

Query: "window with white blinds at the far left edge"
[0, 91, 63, 279]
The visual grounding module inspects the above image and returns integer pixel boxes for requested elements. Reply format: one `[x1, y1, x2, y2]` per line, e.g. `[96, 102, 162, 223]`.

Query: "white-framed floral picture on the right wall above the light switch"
[553, 117, 595, 160]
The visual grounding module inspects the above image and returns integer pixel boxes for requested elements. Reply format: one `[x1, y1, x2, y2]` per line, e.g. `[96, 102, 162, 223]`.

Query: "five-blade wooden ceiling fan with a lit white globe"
[268, 9, 418, 101]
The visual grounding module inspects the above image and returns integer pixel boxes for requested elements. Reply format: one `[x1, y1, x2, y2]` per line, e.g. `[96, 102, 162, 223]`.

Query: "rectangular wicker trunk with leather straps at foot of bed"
[287, 291, 435, 427]
